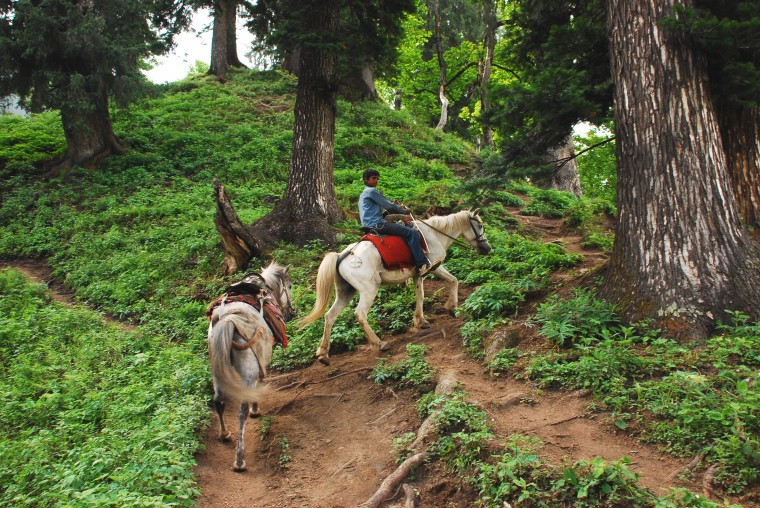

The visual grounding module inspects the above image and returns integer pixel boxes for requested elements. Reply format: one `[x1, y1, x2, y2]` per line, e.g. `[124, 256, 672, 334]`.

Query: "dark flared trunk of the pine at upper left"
[46, 74, 124, 178]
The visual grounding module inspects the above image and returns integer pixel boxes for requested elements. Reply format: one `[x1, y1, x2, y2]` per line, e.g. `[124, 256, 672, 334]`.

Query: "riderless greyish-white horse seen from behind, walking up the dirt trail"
[208, 263, 295, 472]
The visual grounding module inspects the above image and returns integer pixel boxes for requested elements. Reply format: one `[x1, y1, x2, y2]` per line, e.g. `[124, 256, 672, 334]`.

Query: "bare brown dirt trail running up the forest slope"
[4, 212, 700, 508]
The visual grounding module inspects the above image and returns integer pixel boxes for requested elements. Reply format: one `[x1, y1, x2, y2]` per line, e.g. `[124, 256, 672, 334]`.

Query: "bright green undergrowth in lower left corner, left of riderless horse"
[0, 270, 209, 506]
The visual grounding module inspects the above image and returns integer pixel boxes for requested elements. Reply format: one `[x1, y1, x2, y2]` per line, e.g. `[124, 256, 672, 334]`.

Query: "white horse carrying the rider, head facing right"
[297, 210, 491, 365]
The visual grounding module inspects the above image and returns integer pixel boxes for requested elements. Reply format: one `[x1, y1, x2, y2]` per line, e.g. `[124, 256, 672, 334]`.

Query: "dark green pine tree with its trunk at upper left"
[0, 0, 187, 176]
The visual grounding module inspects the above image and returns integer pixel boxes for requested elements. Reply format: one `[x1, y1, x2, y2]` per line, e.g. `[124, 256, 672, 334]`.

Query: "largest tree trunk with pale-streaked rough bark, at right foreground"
[600, 0, 760, 339]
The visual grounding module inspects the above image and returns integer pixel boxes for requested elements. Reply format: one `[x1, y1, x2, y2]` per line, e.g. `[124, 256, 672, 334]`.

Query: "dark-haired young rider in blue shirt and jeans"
[359, 169, 440, 275]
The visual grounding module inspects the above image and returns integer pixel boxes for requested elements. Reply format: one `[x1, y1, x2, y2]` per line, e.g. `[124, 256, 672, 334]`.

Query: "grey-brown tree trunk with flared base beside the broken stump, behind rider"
[254, 0, 343, 245]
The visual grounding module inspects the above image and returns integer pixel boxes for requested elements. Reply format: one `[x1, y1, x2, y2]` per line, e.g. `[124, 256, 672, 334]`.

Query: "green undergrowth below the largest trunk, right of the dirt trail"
[527, 312, 760, 494]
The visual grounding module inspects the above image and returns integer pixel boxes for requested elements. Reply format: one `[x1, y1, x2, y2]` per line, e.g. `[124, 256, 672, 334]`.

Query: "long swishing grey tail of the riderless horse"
[208, 317, 265, 402]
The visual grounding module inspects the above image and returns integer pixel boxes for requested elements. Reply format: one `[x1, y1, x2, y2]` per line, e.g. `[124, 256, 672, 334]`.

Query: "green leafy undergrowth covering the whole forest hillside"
[0, 71, 760, 506]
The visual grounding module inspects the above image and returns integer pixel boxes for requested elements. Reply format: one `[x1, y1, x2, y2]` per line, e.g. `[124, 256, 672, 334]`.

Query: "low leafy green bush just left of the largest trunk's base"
[532, 290, 620, 347]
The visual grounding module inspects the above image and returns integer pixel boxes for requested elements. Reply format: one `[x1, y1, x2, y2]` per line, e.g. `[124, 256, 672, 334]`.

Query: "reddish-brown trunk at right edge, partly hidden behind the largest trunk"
[718, 105, 760, 231]
